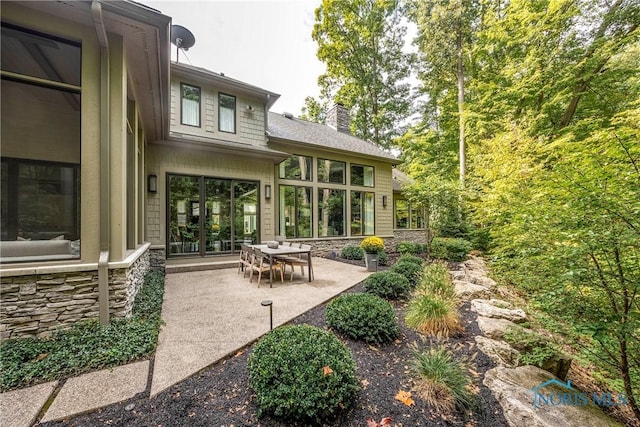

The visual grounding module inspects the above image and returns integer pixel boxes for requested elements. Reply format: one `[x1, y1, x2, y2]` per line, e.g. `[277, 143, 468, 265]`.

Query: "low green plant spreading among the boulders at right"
[504, 327, 560, 368]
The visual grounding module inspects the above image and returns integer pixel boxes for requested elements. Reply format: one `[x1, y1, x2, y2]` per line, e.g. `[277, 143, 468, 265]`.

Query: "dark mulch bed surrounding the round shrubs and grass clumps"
[44, 264, 508, 427]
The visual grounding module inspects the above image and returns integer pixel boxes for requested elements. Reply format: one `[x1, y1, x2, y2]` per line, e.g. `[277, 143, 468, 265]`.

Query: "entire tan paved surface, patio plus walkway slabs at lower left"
[0, 258, 369, 427]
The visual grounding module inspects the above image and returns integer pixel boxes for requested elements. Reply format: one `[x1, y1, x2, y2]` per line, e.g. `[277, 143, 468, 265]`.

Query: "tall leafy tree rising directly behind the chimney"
[307, 0, 412, 148]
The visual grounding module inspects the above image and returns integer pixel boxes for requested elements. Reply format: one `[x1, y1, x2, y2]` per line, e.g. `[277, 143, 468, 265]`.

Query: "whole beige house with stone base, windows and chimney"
[0, 1, 428, 338]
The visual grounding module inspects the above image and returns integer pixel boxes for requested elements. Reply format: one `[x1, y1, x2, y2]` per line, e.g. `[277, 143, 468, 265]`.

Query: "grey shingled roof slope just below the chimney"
[268, 112, 400, 164]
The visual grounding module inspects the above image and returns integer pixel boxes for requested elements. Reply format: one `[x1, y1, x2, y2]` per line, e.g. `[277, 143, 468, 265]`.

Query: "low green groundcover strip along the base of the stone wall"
[0, 272, 164, 390]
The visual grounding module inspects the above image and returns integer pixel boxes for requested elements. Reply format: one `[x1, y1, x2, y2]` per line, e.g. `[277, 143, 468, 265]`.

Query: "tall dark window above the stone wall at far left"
[0, 23, 82, 262]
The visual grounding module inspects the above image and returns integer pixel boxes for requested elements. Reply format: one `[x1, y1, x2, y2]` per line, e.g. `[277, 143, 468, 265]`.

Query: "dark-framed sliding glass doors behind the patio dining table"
[167, 175, 260, 256]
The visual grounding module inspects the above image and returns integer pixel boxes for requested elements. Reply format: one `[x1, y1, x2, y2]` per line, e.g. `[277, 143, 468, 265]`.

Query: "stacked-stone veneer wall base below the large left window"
[0, 250, 150, 339]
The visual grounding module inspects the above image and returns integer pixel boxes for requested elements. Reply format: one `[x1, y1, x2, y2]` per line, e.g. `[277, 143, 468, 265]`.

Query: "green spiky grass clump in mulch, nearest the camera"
[411, 345, 475, 411]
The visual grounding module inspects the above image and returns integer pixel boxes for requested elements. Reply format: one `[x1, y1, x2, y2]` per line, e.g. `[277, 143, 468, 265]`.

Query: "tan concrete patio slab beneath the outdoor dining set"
[151, 257, 369, 396]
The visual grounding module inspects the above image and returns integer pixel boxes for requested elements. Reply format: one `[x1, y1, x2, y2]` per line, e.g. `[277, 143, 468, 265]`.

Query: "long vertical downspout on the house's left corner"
[91, 0, 111, 325]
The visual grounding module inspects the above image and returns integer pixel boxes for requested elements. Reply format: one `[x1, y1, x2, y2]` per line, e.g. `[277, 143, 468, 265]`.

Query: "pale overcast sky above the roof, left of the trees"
[145, 0, 325, 116]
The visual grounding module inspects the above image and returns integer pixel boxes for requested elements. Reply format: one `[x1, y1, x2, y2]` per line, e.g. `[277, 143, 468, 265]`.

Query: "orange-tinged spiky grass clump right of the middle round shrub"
[404, 294, 463, 337]
